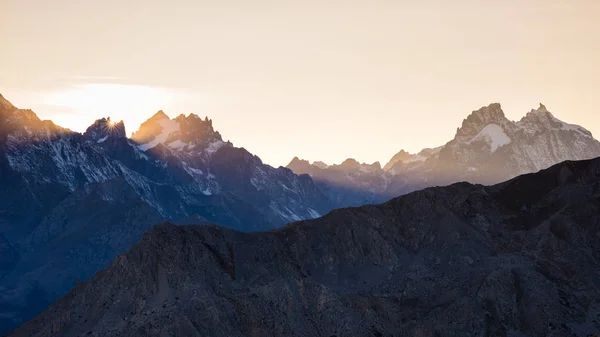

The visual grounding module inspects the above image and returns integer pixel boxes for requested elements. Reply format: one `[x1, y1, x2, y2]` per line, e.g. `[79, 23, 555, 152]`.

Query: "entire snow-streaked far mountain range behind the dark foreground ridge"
[0, 95, 600, 333]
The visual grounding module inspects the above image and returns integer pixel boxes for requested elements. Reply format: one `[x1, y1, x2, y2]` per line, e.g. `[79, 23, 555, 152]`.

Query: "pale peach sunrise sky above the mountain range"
[0, 0, 600, 166]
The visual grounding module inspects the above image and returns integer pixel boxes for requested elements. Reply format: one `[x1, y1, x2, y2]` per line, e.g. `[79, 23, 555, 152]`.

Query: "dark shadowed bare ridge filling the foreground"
[9, 159, 600, 337]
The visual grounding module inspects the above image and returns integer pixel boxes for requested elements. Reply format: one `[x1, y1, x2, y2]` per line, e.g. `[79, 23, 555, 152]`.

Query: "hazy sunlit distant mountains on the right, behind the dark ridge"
[287, 103, 600, 202]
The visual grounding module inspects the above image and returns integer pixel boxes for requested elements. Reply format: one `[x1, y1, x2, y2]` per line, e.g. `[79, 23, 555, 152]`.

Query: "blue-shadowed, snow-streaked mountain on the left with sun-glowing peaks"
[0, 96, 333, 333]
